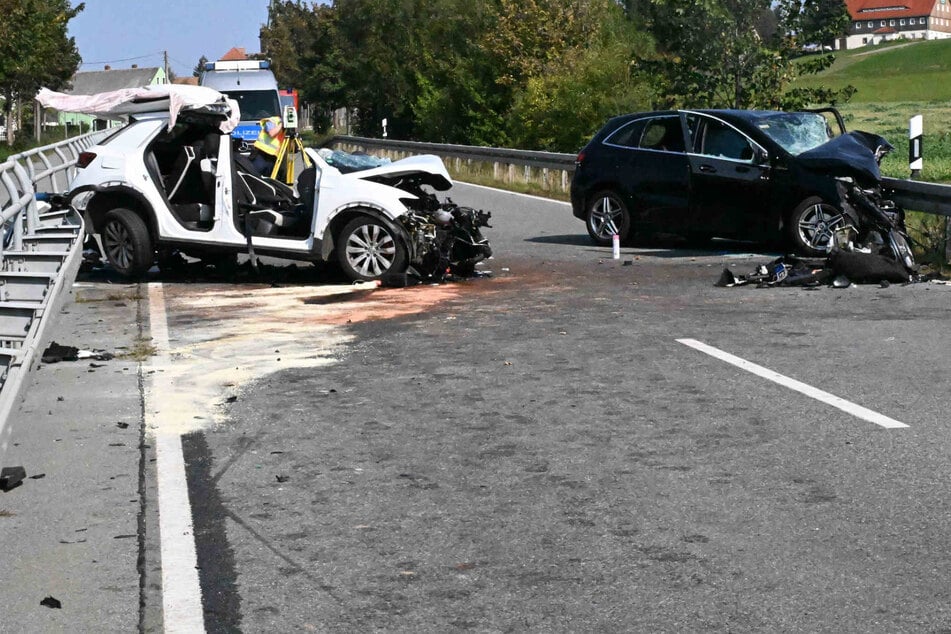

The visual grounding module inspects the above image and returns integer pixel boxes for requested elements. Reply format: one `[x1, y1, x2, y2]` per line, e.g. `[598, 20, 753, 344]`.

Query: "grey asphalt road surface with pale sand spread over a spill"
[0, 180, 951, 632]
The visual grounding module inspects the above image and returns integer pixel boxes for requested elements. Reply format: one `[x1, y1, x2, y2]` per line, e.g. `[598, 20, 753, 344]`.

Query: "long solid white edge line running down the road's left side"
[144, 283, 205, 634]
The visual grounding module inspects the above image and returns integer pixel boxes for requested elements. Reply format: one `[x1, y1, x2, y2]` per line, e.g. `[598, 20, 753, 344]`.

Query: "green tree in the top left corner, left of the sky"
[0, 0, 85, 145]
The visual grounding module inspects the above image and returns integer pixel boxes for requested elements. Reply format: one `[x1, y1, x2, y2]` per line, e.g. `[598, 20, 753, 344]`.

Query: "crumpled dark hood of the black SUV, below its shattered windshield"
[797, 131, 894, 182]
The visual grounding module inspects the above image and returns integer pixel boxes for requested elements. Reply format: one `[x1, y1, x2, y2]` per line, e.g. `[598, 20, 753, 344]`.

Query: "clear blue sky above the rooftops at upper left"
[69, 0, 269, 77]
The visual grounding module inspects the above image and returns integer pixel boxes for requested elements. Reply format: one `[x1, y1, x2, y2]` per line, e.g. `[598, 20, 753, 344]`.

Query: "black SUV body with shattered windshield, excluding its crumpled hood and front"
[571, 108, 860, 255]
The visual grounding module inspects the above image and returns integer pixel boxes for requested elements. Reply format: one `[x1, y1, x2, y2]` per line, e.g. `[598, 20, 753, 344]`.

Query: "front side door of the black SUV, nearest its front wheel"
[685, 113, 776, 239]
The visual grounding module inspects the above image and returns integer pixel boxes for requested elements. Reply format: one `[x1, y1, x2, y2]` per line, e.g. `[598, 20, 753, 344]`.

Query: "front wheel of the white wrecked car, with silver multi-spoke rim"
[336, 216, 406, 280]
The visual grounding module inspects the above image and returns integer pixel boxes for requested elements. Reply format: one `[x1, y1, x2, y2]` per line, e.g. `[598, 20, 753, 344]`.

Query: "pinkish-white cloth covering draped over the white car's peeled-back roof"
[36, 84, 241, 133]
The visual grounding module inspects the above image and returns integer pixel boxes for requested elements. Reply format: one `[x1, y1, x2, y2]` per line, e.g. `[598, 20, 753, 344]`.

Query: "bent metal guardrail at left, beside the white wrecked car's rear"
[0, 130, 108, 467]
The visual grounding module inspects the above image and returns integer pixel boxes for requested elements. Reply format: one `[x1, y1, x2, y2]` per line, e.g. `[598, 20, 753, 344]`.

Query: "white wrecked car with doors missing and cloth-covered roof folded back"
[38, 85, 491, 280]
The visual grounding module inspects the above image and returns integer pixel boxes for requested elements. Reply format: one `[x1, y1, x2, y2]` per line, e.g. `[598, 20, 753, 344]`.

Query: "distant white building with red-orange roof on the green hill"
[837, 0, 951, 49]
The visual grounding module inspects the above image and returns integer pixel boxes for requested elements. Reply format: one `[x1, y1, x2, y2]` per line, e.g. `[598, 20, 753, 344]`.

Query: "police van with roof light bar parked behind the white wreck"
[199, 59, 282, 152]
